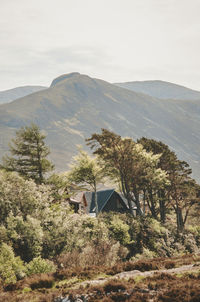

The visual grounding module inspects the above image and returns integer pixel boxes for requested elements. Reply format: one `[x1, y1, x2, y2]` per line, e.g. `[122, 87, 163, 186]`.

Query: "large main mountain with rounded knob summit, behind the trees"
[0, 73, 200, 179]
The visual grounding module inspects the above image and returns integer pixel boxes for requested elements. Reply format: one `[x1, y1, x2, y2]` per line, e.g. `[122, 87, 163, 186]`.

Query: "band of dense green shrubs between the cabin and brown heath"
[0, 171, 200, 284]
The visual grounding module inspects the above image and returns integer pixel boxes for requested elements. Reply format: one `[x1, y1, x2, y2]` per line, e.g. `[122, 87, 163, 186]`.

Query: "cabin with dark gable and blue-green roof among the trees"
[70, 189, 130, 216]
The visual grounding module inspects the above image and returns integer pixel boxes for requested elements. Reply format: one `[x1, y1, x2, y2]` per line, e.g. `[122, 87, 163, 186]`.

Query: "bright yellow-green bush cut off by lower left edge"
[0, 243, 25, 283]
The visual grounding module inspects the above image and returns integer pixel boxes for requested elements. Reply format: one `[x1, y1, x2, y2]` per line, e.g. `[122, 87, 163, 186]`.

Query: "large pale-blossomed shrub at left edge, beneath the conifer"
[0, 170, 52, 225]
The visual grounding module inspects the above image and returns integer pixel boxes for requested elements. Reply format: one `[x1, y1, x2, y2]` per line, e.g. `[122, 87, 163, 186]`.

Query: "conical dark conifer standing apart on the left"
[1, 124, 54, 184]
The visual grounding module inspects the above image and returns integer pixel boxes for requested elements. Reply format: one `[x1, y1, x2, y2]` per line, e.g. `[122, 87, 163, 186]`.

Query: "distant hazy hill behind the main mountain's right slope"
[116, 81, 200, 100]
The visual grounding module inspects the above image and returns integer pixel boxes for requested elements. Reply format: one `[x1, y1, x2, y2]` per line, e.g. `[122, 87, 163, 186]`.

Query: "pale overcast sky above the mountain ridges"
[0, 0, 200, 91]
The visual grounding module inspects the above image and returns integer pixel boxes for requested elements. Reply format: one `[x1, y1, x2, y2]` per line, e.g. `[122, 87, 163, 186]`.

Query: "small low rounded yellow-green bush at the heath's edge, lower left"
[26, 257, 56, 276]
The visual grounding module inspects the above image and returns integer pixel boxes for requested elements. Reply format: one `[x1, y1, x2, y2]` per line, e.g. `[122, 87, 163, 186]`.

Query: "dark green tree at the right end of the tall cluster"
[138, 137, 199, 231]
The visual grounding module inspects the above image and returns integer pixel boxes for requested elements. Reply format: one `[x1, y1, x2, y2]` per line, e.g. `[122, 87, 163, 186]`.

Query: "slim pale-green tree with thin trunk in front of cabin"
[69, 149, 104, 216]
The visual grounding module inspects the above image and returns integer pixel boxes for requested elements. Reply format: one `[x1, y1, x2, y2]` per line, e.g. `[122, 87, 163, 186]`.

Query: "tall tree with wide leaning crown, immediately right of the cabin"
[87, 129, 166, 215]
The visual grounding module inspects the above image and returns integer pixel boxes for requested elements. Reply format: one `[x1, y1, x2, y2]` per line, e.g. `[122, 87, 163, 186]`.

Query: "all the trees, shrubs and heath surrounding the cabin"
[0, 125, 200, 302]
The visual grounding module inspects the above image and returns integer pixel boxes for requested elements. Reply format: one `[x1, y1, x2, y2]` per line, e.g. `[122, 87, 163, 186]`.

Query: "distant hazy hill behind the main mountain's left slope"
[0, 86, 47, 104]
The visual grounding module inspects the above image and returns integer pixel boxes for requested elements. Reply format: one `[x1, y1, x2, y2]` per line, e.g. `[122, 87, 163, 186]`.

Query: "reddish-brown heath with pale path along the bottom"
[0, 254, 200, 302]
